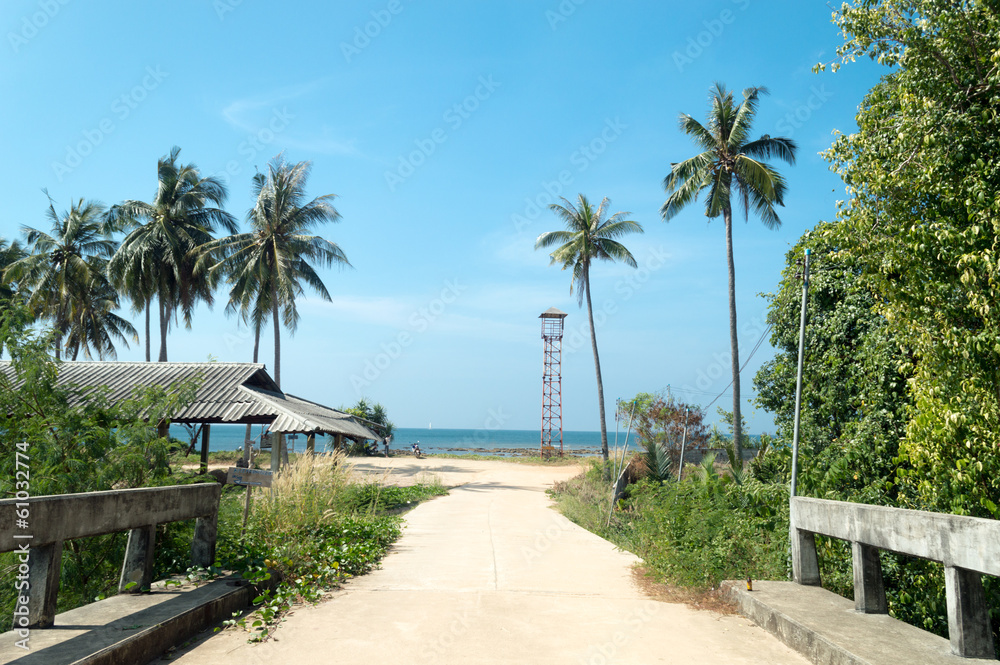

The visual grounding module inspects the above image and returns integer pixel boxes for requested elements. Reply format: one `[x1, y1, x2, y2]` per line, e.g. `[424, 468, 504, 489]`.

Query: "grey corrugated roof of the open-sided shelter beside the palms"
[0, 361, 378, 439]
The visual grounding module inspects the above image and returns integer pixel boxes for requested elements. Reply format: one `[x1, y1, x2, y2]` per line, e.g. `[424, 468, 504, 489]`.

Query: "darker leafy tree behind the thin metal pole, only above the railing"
[754, 223, 911, 505]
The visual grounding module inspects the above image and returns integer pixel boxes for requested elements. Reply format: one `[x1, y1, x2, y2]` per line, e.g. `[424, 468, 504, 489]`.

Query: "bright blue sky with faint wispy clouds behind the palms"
[0, 0, 880, 432]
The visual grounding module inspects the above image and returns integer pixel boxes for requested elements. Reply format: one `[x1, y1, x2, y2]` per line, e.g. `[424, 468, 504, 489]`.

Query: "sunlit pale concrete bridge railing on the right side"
[790, 497, 1000, 658]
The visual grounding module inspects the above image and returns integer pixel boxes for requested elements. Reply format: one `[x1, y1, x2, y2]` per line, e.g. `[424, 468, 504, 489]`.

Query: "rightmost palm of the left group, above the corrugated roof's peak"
[202, 155, 351, 387]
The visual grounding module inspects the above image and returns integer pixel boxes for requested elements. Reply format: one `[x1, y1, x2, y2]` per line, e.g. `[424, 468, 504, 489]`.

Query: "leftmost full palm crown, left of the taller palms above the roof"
[5, 192, 115, 360]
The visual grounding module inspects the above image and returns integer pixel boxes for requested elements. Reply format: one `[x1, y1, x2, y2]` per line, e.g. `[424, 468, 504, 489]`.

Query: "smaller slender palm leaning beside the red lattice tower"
[535, 194, 643, 479]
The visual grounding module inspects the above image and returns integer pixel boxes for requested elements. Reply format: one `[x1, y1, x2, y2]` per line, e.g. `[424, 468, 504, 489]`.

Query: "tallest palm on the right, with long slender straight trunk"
[660, 83, 796, 459]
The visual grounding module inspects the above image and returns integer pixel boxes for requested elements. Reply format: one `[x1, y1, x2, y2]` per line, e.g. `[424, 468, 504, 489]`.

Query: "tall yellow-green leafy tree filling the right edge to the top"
[826, 0, 1000, 518]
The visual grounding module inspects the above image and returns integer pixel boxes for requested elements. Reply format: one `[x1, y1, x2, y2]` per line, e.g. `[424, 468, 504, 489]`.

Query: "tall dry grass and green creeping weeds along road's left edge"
[207, 453, 447, 642]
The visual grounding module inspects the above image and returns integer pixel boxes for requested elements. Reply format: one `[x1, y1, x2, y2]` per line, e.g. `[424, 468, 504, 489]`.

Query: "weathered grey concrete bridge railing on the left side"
[0, 483, 222, 629]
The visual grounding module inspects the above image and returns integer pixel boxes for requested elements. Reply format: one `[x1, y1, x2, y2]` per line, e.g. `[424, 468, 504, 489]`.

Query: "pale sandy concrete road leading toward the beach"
[162, 458, 807, 665]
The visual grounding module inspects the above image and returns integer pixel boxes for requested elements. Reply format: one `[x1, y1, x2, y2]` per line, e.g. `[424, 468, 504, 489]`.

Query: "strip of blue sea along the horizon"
[170, 425, 608, 457]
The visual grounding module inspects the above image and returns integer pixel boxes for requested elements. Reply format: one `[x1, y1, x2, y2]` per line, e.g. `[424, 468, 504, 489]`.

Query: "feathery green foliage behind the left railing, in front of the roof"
[0, 307, 203, 625]
